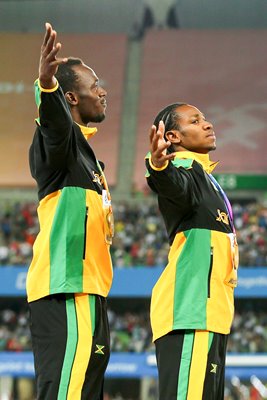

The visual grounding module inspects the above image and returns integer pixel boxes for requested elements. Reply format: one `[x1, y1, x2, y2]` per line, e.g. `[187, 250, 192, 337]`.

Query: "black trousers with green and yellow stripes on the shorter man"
[155, 330, 228, 400]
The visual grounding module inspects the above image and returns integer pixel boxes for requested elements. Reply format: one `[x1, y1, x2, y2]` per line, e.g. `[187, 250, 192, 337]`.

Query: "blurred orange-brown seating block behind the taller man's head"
[0, 33, 127, 187]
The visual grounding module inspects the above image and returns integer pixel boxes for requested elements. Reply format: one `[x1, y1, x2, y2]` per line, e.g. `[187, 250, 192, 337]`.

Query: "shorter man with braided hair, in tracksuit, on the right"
[146, 103, 238, 400]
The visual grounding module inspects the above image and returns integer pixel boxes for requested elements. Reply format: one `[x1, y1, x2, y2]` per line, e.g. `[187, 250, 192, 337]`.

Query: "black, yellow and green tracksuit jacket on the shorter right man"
[146, 151, 238, 340]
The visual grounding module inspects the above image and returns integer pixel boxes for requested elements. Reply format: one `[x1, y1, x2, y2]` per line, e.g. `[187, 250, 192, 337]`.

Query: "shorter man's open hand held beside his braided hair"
[149, 121, 175, 168]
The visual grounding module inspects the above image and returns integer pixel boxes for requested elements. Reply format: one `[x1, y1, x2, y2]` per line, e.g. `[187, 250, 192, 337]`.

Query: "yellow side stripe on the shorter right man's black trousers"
[187, 330, 210, 400]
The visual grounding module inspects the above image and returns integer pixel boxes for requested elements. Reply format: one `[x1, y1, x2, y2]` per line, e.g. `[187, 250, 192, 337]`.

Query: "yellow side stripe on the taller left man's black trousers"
[67, 293, 93, 400]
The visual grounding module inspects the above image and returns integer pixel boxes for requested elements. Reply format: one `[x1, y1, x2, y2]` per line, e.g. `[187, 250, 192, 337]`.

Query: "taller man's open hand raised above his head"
[39, 22, 68, 89]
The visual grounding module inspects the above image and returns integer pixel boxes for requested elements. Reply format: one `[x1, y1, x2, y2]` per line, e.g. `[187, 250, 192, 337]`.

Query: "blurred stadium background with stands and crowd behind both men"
[0, 0, 267, 400]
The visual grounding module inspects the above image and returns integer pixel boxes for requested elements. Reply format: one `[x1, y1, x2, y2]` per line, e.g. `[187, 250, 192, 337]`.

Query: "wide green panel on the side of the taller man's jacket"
[50, 187, 86, 293]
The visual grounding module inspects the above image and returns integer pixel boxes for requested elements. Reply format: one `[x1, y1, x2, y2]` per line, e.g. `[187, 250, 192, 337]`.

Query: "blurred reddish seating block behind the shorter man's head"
[134, 30, 267, 189]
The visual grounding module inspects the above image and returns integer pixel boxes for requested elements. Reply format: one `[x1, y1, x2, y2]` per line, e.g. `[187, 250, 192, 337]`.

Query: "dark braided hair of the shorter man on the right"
[153, 103, 187, 153]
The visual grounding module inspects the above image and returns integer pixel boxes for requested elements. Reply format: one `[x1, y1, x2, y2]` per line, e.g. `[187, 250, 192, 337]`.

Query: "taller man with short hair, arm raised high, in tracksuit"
[27, 23, 113, 400]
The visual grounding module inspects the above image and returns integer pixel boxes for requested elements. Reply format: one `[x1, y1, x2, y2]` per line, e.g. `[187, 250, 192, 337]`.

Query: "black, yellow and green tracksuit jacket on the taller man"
[27, 81, 112, 301]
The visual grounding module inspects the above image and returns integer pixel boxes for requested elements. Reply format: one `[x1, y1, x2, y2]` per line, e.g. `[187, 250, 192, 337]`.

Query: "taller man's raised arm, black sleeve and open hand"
[34, 23, 73, 169]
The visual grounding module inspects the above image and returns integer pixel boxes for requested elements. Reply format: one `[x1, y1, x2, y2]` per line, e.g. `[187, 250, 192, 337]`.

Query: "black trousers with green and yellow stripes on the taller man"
[29, 294, 110, 400]
